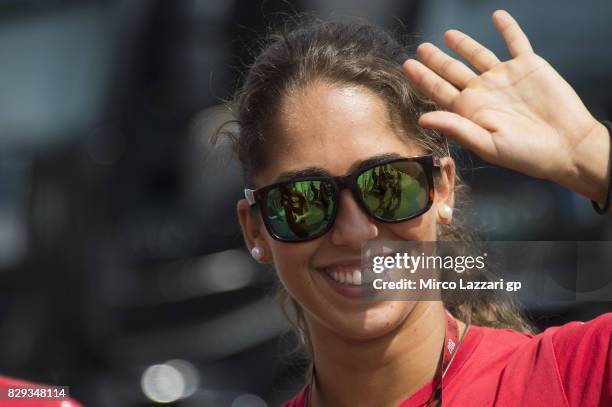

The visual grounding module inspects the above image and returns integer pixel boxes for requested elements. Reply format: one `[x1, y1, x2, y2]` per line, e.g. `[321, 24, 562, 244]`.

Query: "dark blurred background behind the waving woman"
[0, 0, 612, 407]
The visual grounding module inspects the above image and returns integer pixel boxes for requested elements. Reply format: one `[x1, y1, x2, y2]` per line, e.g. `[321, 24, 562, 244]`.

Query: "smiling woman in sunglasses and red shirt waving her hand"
[220, 11, 612, 407]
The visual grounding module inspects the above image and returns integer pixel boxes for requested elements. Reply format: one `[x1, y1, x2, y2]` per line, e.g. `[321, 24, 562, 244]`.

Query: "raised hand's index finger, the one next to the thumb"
[404, 59, 459, 109]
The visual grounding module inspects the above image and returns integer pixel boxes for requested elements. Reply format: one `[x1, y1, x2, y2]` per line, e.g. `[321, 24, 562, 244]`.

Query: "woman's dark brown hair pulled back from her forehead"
[215, 16, 532, 360]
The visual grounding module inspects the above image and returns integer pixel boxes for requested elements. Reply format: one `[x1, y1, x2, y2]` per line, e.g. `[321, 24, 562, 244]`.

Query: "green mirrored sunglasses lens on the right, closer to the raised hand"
[357, 161, 429, 220]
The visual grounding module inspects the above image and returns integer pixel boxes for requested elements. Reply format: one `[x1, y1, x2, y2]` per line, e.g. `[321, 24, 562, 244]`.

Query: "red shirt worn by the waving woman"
[284, 313, 612, 407]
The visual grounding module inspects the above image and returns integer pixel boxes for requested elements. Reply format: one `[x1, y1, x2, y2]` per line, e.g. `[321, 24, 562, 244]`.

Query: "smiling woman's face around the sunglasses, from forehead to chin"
[238, 82, 454, 339]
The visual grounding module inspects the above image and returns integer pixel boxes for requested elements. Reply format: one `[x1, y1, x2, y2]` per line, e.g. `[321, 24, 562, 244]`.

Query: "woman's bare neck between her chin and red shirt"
[309, 301, 456, 407]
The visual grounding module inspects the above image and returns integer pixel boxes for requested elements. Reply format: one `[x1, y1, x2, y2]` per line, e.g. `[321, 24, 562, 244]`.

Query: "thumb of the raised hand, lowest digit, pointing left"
[419, 111, 496, 161]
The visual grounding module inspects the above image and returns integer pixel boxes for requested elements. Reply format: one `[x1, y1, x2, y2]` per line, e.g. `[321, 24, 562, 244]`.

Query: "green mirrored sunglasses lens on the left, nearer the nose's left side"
[266, 181, 334, 240]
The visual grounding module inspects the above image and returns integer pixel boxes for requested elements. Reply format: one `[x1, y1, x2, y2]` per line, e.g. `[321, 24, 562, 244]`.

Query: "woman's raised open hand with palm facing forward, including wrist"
[404, 10, 611, 202]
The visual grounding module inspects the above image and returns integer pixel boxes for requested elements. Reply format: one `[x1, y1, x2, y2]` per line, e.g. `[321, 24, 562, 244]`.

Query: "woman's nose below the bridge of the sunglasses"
[331, 189, 378, 250]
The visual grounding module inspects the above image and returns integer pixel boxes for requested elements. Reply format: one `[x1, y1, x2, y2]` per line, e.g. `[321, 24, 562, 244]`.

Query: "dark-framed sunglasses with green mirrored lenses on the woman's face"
[244, 155, 440, 242]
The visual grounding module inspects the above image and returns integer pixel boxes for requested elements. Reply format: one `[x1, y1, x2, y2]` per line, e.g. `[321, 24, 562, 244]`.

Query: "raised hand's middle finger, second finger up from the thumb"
[417, 43, 476, 89]
